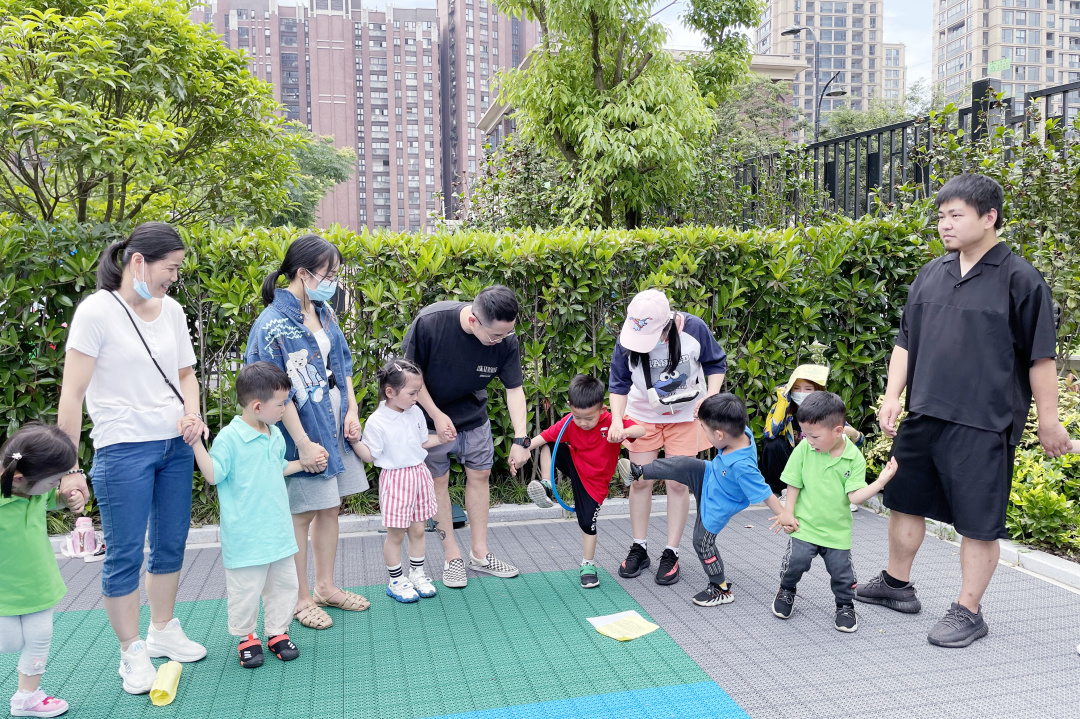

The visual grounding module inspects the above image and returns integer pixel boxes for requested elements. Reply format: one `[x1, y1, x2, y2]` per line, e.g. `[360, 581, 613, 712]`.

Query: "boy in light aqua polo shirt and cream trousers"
[194, 362, 308, 668]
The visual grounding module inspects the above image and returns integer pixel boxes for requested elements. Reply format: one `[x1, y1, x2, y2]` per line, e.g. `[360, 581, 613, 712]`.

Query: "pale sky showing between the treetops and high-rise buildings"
[653, 0, 933, 84]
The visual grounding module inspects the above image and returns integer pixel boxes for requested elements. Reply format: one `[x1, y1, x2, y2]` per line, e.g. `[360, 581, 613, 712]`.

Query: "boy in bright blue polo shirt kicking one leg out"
[619, 392, 794, 607]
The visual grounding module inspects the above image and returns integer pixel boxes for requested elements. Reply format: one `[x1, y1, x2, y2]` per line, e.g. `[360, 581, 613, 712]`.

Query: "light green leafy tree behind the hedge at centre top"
[500, 0, 712, 228]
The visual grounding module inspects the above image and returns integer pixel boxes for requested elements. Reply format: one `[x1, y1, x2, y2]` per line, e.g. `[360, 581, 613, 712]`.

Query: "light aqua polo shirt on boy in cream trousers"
[210, 415, 298, 569]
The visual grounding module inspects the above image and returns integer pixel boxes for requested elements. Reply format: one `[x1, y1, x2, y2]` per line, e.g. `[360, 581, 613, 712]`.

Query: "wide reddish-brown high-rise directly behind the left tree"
[193, 0, 443, 231]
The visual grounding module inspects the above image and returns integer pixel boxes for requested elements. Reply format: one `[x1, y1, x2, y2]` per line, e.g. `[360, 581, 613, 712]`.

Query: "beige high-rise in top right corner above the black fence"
[933, 0, 1080, 101]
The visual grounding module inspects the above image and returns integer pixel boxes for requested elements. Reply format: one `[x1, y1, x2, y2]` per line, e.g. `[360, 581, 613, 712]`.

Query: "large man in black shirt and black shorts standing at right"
[855, 175, 1070, 647]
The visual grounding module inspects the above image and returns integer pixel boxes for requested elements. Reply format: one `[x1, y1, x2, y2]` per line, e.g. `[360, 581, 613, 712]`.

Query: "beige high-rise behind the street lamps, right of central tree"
[754, 0, 906, 127]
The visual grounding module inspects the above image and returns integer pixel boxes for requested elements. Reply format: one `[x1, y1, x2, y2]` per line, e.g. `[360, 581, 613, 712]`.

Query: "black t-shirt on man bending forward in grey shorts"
[402, 301, 522, 432]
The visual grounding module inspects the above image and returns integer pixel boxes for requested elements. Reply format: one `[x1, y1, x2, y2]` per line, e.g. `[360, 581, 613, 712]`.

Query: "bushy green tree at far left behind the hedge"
[0, 0, 299, 222]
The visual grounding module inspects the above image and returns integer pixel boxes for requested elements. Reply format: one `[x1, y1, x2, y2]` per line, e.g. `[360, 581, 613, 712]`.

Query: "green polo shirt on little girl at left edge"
[0, 489, 67, 616]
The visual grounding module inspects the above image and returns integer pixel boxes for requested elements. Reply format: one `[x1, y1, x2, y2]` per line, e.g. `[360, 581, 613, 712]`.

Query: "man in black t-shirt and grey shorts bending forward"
[403, 285, 529, 587]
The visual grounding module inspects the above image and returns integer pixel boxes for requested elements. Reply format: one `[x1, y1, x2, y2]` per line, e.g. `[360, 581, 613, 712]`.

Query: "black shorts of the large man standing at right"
[885, 415, 1016, 541]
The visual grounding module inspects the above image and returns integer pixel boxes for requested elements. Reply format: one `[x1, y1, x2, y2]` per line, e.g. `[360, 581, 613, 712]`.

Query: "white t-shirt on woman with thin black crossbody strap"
[67, 290, 195, 448]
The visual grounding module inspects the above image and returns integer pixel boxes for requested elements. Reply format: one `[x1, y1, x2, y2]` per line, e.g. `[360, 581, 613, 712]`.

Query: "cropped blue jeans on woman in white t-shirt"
[90, 437, 194, 597]
